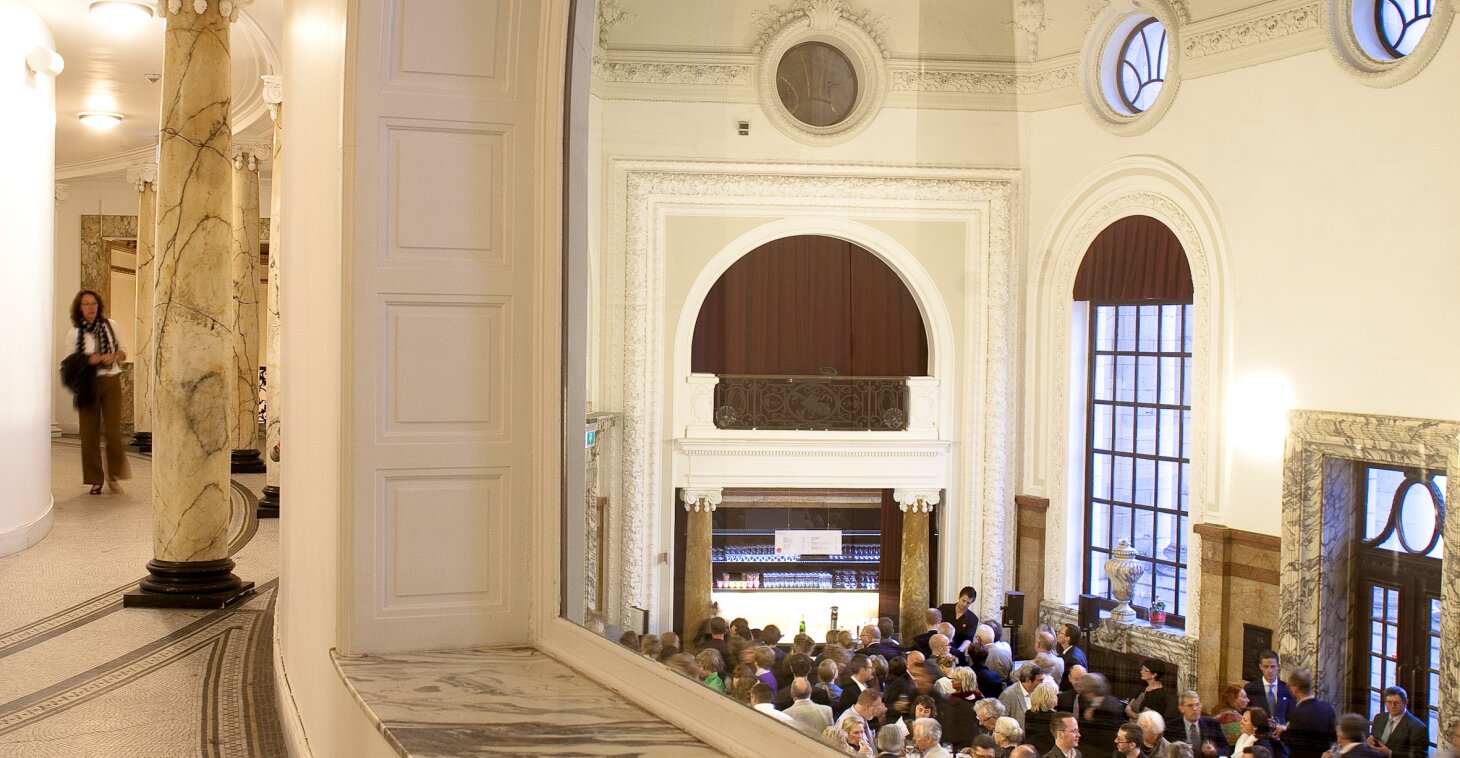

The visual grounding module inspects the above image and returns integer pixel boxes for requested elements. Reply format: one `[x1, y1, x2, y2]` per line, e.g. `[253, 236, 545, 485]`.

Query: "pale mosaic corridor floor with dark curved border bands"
[0, 438, 285, 758]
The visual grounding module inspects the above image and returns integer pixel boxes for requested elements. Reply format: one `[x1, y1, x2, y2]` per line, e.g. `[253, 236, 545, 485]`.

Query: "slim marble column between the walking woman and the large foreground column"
[127, 164, 158, 453]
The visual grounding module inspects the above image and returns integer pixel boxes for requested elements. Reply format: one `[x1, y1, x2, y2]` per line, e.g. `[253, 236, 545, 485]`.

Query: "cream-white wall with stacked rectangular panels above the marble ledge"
[346, 0, 552, 651]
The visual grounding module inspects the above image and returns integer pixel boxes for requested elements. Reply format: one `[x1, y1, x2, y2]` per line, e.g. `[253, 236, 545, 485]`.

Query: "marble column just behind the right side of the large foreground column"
[228, 143, 272, 473]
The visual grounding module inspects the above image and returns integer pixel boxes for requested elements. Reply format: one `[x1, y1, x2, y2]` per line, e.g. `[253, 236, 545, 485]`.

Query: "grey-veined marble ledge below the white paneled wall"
[331, 647, 721, 758]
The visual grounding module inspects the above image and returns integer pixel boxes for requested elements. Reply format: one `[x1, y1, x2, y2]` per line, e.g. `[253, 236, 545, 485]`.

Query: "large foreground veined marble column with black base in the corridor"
[124, 0, 254, 608]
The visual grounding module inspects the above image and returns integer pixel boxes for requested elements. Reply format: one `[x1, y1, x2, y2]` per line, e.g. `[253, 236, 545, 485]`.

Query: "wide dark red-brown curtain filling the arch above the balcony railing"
[691, 235, 927, 377]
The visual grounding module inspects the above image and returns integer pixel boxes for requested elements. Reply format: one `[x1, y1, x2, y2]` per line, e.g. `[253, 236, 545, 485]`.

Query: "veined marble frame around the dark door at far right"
[1278, 410, 1460, 723]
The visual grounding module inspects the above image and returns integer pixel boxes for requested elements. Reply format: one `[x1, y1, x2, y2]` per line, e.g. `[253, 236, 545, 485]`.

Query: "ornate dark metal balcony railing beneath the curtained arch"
[715, 374, 908, 431]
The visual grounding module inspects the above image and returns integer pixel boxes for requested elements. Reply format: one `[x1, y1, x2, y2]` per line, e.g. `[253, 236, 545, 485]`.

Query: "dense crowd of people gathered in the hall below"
[598, 587, 1460, 758]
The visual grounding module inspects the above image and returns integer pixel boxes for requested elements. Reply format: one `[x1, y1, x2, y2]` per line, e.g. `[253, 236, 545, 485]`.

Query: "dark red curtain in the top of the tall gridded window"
[1075, 216, 1191, 302]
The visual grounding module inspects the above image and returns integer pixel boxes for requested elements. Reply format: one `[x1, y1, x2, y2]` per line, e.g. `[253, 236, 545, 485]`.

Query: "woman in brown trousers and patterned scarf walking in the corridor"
[66, 289, 131, 495]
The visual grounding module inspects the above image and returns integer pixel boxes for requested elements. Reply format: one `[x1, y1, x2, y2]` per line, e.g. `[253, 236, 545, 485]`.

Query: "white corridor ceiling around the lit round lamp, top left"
[26, 0, 285, 178]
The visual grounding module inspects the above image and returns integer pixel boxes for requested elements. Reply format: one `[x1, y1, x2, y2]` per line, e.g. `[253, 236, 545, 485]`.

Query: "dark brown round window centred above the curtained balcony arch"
[775, 41, 858, 127]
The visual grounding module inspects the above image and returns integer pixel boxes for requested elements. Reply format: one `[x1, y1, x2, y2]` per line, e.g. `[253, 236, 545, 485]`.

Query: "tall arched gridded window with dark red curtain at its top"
[1073, 216, 1196, 625]
